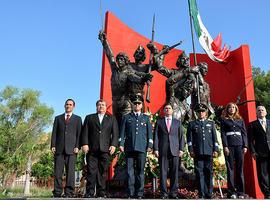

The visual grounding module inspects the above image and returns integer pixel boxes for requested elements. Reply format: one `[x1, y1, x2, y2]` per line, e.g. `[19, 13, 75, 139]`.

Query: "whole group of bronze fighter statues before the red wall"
[99, 31, 214, 124]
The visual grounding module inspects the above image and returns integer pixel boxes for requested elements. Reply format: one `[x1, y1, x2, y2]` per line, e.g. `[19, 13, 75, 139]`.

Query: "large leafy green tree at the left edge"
[0, 86, 53, 188]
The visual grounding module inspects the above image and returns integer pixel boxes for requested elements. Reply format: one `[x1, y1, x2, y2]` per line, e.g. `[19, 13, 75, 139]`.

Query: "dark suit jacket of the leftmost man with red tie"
[51, 114, 82, 154]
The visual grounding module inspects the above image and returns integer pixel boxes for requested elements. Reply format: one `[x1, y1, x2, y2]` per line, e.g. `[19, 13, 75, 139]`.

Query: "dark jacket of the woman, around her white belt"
[220, 119, 248, 148]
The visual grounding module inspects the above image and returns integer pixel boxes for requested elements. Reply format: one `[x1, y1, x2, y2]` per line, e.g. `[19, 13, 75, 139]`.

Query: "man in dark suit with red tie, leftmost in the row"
[51, 99, 82, 197]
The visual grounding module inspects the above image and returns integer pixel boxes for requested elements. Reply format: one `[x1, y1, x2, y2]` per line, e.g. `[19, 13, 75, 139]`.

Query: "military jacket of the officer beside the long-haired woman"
[187, 120, 218, 156]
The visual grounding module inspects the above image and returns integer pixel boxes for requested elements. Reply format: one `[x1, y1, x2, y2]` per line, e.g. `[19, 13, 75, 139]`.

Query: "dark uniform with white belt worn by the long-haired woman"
[221, 118, 248, 196]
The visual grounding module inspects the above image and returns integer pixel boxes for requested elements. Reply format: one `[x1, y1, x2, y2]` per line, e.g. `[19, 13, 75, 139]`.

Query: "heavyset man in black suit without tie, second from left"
[82, 100, 119, 198]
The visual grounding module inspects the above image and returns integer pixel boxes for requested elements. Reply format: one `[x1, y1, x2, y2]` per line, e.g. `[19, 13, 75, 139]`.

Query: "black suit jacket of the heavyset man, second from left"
[82, 113, 119, 152]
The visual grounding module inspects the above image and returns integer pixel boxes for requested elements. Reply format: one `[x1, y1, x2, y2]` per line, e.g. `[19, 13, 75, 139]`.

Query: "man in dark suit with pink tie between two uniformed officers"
[154, 104, 185, 199]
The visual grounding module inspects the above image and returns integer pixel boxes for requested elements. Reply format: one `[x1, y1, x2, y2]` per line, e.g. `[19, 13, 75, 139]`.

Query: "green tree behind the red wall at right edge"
[252, 67, 270, 112]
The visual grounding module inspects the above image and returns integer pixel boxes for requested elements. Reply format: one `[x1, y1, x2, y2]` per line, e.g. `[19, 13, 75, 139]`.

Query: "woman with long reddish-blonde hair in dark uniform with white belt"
[220, 102, 248, 199]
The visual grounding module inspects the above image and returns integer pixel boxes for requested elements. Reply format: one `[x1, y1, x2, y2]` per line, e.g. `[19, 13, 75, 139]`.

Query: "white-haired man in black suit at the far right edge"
[248, 106, 270, 199]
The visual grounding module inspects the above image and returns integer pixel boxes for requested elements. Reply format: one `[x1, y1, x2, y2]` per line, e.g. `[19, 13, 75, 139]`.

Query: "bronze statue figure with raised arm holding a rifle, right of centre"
[148, 44, 197, 121]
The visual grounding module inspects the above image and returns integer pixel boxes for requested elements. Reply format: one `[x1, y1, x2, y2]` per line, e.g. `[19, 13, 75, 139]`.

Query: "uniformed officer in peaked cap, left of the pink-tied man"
[119, 95, 153, 199]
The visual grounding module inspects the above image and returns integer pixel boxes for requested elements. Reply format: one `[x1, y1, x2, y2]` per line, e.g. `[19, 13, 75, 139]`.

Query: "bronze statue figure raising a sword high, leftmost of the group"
[98, 31, 152, 125]
